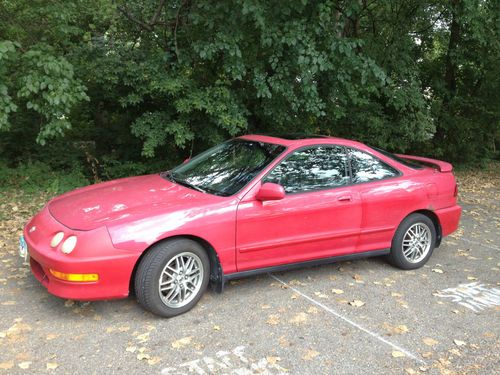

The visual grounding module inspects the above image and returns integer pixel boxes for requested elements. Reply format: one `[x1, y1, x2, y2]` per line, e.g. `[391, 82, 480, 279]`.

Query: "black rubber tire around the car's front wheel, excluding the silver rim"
[134, 238, 210, 318]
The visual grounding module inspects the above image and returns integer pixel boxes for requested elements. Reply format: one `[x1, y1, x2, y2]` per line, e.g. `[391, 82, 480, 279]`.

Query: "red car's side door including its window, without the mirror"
[236, 145, 361, 271]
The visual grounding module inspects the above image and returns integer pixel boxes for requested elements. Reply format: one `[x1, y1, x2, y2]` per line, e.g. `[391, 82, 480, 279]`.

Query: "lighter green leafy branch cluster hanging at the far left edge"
[0, 40, 89, 146]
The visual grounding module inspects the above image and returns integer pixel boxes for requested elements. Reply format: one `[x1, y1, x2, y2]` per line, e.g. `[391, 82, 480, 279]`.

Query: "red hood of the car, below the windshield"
[48, 174, 218, 230]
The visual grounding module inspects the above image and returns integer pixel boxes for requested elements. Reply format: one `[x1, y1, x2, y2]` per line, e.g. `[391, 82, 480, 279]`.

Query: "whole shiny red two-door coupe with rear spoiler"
[20, 135, 461, 317]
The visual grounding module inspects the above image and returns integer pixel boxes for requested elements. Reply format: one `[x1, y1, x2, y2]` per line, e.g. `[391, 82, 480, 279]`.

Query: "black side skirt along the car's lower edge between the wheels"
[212, 249, 391, 293]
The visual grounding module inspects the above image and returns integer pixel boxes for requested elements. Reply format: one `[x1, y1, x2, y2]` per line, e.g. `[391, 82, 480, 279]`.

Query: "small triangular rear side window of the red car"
[349, 149, 399, 184]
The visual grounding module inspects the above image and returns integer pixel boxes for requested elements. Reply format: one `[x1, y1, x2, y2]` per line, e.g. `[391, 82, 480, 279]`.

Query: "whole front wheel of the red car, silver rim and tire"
[134, 239, 210, 317]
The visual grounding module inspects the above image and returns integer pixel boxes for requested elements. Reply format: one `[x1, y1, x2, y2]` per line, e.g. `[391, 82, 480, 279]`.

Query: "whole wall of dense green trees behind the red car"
[0, 0, 500, 184]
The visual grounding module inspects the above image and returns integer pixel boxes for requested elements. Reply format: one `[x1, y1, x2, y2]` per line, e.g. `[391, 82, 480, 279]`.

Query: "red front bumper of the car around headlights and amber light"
[24, 207, 140, 301]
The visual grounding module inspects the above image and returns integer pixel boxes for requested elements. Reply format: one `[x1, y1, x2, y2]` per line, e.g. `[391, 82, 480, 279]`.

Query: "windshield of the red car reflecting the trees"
[162, 138, 285, 196]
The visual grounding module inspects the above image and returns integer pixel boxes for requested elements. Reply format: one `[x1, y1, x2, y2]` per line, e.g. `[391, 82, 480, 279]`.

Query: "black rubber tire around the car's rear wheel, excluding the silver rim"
[387, 214, 436, 270]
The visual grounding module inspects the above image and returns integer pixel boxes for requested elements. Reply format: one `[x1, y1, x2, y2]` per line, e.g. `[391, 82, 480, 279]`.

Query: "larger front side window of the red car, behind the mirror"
[264, 146, 349, 194]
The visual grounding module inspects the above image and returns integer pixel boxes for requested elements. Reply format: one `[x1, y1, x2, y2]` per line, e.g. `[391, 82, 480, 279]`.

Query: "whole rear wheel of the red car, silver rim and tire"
[388, 214, 436, 270]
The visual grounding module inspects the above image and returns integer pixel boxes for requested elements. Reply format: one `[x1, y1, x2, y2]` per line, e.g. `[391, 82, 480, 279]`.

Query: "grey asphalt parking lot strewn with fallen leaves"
[0, 171, 500, 375]
